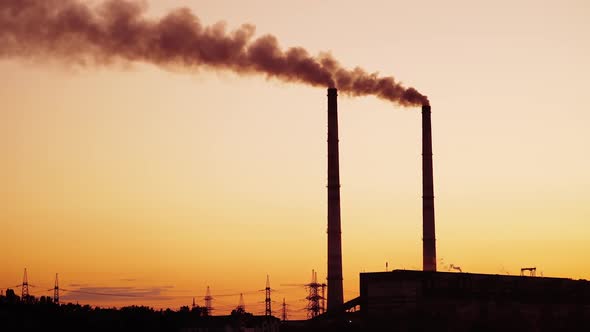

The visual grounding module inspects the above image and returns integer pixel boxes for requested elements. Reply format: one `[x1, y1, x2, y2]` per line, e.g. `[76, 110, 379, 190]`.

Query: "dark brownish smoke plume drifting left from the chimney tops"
[0, 0, 428, 106]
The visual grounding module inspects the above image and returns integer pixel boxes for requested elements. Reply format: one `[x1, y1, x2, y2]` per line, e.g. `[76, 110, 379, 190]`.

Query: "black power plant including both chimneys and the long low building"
[296, 99, 590, 331]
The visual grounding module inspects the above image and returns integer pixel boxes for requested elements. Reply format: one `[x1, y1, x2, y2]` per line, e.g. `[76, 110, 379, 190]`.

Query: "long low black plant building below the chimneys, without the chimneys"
[360, 270, 590, 331]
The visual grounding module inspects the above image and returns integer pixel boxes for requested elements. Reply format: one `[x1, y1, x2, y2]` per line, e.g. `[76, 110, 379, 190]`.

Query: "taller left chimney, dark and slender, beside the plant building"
[328, 88, 344, 312]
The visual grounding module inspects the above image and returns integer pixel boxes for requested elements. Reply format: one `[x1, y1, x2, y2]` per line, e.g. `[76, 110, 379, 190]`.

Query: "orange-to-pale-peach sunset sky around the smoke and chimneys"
[0, 0, 590, 318]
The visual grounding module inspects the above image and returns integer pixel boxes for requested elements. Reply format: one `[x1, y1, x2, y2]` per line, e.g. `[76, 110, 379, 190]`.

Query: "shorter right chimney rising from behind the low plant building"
[422, 105, 436, 271]
